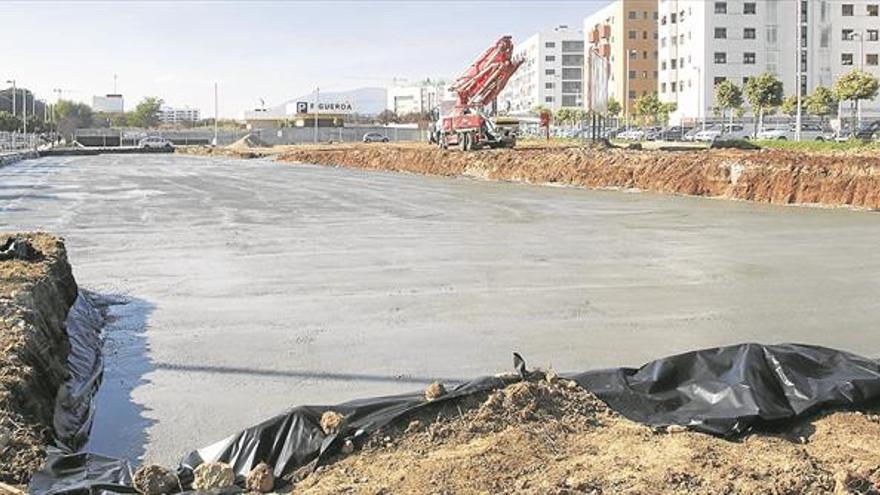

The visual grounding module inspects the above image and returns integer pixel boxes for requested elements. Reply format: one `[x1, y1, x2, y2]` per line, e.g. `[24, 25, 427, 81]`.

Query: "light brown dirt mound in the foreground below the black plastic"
[294, 377, 880, 494]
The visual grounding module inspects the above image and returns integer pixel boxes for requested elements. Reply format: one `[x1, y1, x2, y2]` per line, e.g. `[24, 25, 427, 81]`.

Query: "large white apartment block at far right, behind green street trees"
[658, 0, 880, 123]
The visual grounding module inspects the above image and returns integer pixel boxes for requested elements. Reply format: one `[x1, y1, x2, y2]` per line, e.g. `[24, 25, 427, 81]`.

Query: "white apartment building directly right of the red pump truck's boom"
[498, 25, 584, 115]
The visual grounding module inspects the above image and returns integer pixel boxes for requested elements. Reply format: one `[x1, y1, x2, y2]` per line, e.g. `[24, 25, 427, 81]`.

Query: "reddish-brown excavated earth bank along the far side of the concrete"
[278, 144, 880, 209]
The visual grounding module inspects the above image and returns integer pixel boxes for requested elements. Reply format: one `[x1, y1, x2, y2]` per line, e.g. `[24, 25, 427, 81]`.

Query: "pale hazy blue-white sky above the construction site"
[0, 0, 609, 118]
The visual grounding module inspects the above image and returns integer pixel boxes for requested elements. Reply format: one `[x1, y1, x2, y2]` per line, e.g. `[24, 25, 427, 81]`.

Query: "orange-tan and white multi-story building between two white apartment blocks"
[584, 0, 658, 115]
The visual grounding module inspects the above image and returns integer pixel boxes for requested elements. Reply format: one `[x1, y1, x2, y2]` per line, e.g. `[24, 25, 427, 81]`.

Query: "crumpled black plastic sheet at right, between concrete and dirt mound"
[571, 344, 880, 436]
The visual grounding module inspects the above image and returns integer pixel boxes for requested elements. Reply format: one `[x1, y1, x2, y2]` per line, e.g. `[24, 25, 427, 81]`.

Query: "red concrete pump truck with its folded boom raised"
[432, 36, 523, 151]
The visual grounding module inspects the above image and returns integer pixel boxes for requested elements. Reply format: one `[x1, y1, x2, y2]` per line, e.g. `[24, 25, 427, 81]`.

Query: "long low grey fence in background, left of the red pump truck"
[74, 126, 428, 146]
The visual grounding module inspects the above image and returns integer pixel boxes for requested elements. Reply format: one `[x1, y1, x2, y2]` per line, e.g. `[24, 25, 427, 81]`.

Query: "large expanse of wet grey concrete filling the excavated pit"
[0, 155, 880, 464]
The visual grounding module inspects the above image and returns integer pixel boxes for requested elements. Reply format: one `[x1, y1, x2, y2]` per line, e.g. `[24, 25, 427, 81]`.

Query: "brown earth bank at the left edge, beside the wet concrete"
[0, 233, 77, 484]
